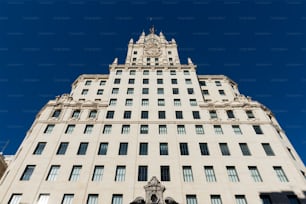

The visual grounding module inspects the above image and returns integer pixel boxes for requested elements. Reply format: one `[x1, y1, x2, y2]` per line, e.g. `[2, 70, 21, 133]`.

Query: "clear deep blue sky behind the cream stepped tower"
[0, 0, 306, 163]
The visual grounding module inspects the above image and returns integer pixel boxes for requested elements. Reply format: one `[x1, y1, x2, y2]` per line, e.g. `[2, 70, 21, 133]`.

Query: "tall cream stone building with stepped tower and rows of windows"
[0, 29, 306, 204]
